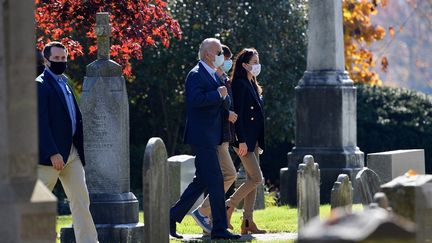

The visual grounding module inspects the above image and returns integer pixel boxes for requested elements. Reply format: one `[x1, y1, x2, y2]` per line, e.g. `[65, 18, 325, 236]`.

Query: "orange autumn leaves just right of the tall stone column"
[342, 0, 391, 85]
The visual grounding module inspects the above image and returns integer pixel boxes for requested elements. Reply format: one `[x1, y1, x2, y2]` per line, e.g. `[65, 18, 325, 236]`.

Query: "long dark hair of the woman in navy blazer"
[231, 48, 262, 95]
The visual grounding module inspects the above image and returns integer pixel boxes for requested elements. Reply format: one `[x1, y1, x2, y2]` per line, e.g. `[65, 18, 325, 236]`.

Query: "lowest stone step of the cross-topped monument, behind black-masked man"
[60, 223, 144, 243]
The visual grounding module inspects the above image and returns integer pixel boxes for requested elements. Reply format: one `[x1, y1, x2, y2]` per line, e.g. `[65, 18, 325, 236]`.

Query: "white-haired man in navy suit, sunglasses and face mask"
[170, 38, 240, 239]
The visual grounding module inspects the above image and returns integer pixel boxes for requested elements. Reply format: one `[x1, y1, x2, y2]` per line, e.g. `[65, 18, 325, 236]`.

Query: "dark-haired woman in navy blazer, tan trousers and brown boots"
[226, 49, 266, 234]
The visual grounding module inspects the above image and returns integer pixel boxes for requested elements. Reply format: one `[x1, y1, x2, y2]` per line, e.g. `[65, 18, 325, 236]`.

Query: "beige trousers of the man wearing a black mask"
[38, 145, 98, 243]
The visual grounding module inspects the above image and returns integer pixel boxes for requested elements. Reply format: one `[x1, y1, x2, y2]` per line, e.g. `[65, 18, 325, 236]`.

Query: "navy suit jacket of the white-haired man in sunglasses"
[184, 63, 231, 146]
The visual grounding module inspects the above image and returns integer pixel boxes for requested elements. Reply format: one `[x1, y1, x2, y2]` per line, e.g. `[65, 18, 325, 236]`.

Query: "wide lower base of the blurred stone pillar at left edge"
[0, 180, 57, 243]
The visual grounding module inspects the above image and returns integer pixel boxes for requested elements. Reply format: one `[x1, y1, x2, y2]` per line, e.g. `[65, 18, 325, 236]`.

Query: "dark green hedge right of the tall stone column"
[357, 85, 432, 173]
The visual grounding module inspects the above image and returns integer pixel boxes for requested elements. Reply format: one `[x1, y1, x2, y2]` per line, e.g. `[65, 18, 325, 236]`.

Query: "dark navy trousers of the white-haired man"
[170, 145, 228, 235]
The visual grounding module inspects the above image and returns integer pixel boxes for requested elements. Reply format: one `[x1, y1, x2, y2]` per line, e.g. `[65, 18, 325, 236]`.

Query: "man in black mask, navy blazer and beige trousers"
[36, 42, 98, 243]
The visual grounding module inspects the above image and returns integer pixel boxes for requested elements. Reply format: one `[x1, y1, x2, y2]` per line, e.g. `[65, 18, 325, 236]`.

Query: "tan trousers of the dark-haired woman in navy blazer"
[226, 145, 263, 219]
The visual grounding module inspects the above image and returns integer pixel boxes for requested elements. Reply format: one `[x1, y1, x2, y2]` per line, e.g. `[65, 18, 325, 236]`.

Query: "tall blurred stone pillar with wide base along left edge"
[0, 0, 57, 243]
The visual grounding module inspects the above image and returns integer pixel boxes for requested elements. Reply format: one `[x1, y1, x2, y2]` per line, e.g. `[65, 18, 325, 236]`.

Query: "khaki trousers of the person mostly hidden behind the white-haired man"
[199, 142, 237, 216]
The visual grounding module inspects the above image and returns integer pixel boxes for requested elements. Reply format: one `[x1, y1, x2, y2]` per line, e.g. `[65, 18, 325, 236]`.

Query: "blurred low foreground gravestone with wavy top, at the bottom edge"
[298, 207, 415, 243]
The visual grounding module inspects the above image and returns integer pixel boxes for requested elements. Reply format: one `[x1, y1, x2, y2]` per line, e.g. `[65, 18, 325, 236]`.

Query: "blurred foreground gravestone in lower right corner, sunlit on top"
[381, 175, 432, 243]
